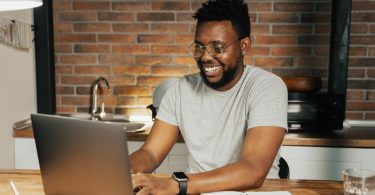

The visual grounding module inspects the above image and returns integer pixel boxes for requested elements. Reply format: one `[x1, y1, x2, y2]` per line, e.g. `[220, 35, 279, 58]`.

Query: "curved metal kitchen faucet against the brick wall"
[91, 76, 111, 120]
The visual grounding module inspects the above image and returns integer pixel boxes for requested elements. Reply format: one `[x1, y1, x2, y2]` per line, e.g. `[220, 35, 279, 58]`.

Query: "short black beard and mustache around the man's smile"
[198, 56, 241, 89]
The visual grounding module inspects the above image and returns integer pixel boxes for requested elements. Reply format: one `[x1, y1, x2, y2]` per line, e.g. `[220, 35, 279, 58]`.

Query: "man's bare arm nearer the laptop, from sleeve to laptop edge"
[129, 119, 179, 173]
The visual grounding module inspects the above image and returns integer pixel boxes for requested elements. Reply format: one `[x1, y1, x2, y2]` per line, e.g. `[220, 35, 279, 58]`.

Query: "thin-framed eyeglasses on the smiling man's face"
[188, 40, 240, 58]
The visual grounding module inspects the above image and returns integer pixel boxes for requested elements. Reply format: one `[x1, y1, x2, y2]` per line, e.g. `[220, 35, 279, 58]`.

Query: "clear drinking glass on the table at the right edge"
[342, 169, 375, 195]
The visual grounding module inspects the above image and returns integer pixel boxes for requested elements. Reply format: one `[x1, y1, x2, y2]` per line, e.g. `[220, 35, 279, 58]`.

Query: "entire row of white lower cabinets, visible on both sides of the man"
[15, 138, 375, 180]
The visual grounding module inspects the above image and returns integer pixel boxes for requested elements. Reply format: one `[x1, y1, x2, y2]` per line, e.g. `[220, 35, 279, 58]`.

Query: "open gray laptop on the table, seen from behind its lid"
[31, 114, 133, 195]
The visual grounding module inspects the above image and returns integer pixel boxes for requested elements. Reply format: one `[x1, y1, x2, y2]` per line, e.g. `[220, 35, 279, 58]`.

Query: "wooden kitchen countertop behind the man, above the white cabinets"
[13, 127, 375, 148]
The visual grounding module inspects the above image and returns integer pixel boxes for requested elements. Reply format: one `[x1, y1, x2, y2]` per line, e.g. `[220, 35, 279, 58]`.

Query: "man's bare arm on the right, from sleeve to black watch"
[188, 126, 285, 194]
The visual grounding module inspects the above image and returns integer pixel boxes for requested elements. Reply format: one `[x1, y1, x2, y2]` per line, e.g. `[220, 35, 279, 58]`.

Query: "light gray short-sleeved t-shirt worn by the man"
[156, 65, 288, 178]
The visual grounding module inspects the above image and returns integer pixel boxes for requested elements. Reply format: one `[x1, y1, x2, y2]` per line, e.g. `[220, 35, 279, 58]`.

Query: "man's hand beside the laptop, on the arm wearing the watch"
[132, 173, 180, 195]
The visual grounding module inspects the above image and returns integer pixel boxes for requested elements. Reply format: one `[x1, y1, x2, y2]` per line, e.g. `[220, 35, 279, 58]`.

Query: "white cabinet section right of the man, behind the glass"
[281, 146, 375, 180]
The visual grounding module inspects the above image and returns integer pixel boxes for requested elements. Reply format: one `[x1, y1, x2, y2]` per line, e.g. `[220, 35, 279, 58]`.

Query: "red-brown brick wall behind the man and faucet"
[53, 0, 375, 119]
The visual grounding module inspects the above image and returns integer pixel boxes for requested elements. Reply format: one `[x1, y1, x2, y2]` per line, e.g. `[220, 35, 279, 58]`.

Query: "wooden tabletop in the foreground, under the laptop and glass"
[0, 170, 343, 195]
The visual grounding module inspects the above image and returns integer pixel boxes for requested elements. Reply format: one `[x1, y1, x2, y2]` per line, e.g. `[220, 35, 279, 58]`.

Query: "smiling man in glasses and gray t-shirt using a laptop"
[130, 0, 287, 194]
